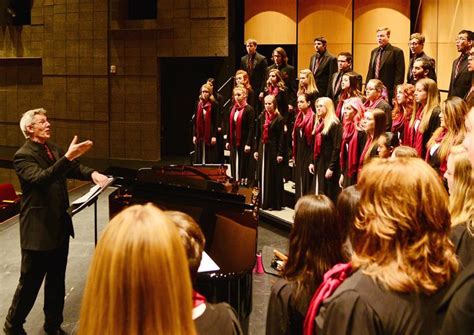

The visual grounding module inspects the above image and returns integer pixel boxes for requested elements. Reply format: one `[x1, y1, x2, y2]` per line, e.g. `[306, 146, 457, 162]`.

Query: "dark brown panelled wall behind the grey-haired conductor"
[0, 0, 229, 160]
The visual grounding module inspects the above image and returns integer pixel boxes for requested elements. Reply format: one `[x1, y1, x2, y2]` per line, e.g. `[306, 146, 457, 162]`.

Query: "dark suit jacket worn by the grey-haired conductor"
[13, 139, 94, 250]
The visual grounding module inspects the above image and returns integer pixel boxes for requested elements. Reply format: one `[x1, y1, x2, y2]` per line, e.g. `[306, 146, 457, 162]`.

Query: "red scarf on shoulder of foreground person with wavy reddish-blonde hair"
[303, 263, 352, 335]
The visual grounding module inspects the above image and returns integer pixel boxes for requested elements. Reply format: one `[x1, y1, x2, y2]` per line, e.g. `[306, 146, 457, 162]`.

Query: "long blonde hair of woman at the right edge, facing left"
[448, 145, 474, 230]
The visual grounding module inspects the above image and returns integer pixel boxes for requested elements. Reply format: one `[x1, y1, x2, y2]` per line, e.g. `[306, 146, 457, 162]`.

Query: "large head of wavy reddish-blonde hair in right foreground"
[352, 158, 458, 294]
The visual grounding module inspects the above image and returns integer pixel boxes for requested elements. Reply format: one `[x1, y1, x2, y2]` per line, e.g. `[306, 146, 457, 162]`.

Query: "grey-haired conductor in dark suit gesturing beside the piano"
[4, 108, 107, 334]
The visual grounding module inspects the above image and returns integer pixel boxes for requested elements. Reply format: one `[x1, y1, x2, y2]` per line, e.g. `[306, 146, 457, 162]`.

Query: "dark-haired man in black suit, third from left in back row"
[309, 37, 337, 97]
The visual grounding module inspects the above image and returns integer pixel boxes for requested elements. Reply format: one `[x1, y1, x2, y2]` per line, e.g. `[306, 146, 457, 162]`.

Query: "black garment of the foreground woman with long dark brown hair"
[265, 279, 317, 335]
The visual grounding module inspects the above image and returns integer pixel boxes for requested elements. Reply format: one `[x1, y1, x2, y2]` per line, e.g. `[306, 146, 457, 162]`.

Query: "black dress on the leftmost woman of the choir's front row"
[193, 101, 220, 164]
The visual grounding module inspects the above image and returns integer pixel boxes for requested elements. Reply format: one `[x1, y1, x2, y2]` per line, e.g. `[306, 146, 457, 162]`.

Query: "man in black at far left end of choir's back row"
[240, 39, 268, 96]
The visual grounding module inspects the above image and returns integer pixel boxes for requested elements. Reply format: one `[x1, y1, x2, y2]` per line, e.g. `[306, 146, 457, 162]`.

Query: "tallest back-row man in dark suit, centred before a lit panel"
[365, 27, 405, 103]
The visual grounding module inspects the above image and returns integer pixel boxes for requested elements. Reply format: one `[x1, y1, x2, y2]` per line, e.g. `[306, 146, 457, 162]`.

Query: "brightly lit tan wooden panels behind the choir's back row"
[244, 0, 474, 89]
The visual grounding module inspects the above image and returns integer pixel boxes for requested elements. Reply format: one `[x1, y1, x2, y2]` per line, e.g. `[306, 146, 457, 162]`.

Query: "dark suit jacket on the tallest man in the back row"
[365, 43, 405, 103]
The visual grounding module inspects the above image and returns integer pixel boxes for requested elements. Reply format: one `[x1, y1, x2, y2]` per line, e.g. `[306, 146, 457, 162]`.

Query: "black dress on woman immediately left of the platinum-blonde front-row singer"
[293, 112, 315, 202]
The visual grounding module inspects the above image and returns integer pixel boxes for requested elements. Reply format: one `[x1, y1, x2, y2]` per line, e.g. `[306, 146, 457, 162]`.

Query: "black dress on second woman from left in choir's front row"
[227, 105, 255, 181]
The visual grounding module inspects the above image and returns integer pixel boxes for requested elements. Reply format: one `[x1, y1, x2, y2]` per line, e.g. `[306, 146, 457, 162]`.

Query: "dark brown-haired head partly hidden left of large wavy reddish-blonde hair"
[336, 185, 360, 252]
